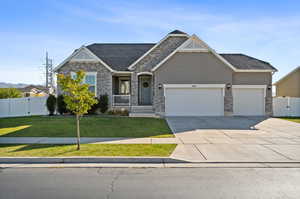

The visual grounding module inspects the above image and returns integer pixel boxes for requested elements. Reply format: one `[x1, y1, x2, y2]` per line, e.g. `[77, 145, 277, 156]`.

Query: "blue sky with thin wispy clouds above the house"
[0, 0, 300, 84]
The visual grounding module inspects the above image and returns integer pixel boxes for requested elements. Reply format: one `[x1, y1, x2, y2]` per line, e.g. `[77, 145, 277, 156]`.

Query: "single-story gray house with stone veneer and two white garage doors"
[55, 30, 277, 116]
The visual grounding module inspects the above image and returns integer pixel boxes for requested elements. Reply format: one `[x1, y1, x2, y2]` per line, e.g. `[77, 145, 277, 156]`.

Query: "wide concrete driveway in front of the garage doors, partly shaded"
[167, 117, 300, 162]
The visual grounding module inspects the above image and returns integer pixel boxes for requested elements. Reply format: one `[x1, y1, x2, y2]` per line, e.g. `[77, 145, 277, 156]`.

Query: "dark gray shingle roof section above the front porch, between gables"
[87, 43, 155, 71]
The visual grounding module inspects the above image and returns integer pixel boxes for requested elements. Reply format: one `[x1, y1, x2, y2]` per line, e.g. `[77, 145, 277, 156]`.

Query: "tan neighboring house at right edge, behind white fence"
[274, 66, 300, 97]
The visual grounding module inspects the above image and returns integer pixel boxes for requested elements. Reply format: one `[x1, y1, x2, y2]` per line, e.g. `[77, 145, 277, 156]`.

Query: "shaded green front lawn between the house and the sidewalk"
[0, 116, 174, 138]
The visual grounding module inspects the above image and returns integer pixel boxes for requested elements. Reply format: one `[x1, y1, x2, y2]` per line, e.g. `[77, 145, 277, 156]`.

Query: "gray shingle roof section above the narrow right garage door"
[220, 54, 277, 71]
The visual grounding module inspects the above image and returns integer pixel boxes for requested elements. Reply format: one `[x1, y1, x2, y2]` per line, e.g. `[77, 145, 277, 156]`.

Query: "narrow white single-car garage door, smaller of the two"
[232, 88, 265, 116]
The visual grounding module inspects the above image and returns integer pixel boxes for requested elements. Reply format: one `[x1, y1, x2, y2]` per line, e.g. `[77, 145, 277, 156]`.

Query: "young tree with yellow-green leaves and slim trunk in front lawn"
[58, 70, 97, 150]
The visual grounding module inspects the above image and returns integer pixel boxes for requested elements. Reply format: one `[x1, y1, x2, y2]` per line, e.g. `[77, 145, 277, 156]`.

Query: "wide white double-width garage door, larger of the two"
[165, 88, 224, 116]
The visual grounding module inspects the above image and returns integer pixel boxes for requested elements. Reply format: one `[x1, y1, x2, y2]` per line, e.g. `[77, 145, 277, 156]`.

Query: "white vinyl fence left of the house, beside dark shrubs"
[0, 96, 49, 117]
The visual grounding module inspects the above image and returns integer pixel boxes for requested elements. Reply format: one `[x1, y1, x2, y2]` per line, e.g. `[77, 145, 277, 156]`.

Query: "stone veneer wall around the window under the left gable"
[57, 62, 112, 107]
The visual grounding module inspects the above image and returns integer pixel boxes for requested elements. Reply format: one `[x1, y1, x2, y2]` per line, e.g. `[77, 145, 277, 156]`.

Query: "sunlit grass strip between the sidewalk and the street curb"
[0, 144, 176, 157]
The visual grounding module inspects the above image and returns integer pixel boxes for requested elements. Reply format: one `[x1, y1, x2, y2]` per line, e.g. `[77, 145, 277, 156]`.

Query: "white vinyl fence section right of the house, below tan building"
[273, 97, 300, 117]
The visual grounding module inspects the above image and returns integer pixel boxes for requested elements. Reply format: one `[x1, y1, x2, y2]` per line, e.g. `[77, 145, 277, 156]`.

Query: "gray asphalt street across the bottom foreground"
[0, 168, 300, 199]
